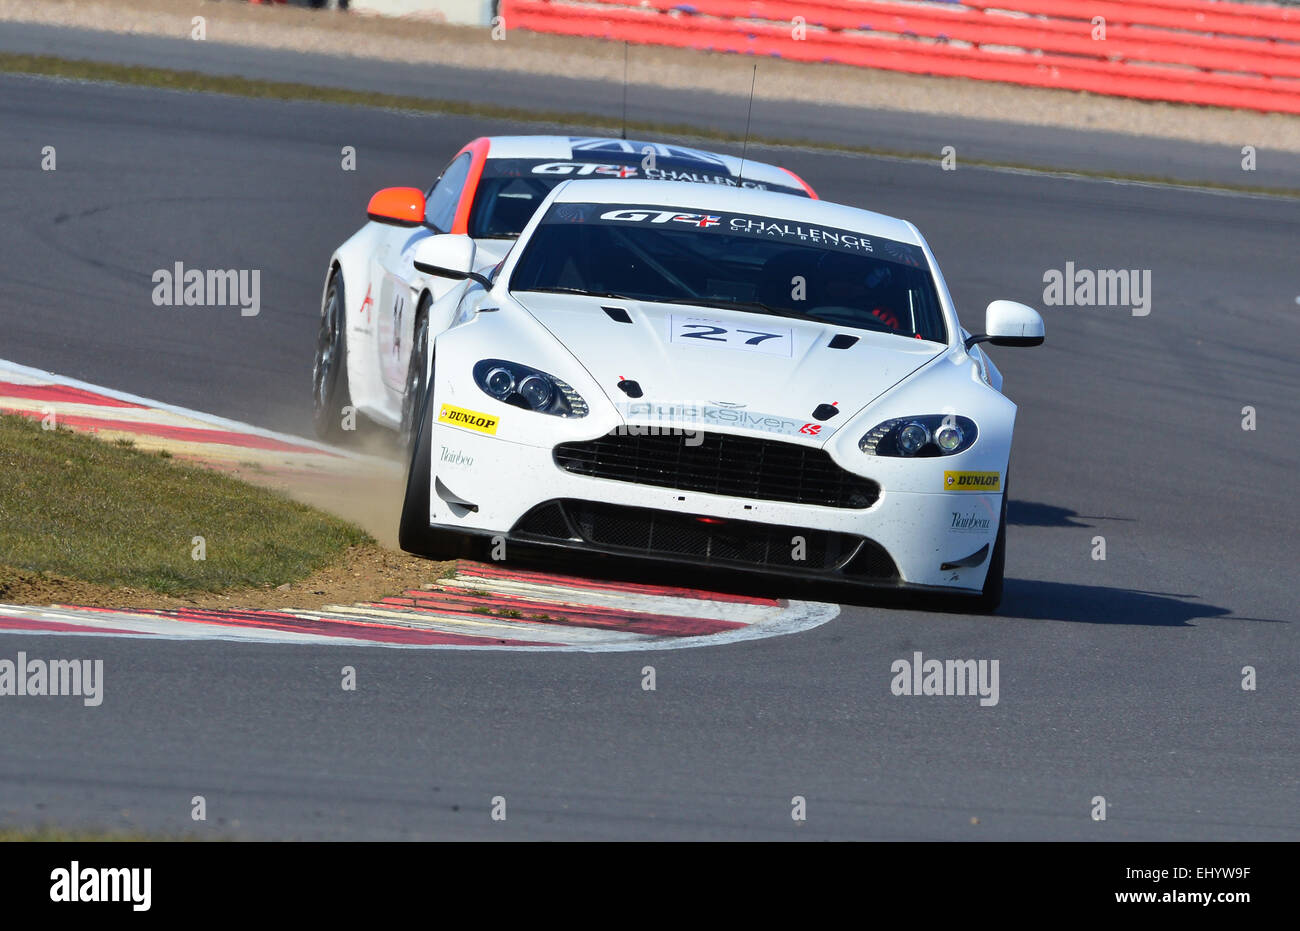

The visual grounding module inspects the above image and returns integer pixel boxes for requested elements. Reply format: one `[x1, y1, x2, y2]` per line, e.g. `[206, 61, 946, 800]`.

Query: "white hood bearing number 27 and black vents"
[511, 291, 948, 445]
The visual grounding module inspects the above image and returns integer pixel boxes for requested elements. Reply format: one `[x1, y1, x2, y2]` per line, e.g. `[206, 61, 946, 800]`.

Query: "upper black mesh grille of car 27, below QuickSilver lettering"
[555, 430, 880, 508]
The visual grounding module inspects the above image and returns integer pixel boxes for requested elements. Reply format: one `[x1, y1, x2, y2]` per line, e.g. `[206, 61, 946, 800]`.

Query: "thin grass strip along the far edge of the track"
[0, 52, 1300, 198]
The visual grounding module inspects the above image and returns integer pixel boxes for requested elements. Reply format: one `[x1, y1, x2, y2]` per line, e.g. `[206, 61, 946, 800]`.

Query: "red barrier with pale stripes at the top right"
[501, 0, 1300, 113]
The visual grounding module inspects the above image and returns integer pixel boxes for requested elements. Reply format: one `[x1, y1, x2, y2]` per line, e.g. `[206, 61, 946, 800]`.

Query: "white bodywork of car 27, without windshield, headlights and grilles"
[405, 181, 1034, 592]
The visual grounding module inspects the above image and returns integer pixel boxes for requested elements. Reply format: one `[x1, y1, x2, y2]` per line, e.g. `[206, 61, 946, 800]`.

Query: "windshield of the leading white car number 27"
[510, 203, 948, 342]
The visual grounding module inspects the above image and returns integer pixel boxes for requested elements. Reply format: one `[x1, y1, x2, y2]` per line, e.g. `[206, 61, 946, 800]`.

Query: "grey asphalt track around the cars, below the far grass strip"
[0, 75, 1300, 840]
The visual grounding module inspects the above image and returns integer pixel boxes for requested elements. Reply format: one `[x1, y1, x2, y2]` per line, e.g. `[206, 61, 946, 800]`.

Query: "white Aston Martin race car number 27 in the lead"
[399, 181, 1044, 610]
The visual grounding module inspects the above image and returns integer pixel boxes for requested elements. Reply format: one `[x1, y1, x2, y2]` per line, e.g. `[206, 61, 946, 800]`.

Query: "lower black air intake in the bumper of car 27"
[512, 501, 868, 572]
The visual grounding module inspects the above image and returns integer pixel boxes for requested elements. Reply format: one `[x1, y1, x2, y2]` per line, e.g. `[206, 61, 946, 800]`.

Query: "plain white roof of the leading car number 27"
[554, 179, 924, 246]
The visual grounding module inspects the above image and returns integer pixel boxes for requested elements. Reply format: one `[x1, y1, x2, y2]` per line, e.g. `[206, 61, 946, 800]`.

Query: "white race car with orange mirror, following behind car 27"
[312, 135, 816, 442]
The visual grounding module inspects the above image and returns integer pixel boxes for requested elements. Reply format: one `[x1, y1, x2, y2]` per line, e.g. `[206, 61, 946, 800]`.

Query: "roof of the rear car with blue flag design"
[488, 135, 802, 190]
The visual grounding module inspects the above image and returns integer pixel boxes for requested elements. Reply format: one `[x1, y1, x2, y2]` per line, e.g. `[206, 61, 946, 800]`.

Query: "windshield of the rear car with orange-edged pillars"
[469, 156, 807, 239]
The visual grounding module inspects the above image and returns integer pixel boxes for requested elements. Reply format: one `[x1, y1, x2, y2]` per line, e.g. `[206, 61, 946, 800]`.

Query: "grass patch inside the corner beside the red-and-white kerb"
[0, 415, 373, 594]
